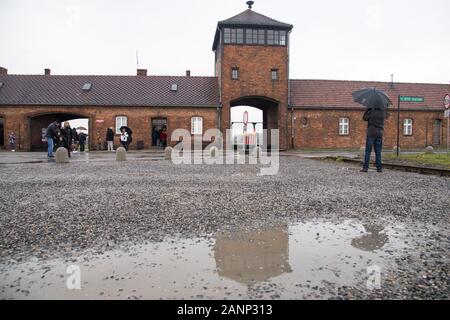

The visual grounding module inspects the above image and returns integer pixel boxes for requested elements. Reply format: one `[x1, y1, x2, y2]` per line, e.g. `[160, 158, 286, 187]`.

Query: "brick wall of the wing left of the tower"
[0, 106, 217, 151]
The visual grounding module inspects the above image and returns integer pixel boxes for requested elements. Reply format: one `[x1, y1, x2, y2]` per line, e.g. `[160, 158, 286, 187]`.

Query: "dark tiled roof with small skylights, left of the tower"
[0, 75, 219, 107]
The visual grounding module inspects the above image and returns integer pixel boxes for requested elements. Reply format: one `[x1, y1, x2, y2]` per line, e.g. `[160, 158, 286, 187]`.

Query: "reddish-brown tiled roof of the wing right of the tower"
[290, 80, 450, 110]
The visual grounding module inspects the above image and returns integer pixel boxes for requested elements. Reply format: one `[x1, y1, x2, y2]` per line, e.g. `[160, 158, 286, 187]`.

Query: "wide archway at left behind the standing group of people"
[30, 113, 90, 151]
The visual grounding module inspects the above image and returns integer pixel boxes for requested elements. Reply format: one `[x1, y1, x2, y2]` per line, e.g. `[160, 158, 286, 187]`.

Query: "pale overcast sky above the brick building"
[0, 0, 450, 83]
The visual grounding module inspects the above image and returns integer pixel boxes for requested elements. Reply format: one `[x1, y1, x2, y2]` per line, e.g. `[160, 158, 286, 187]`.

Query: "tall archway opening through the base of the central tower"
[230, 97, 279, 150]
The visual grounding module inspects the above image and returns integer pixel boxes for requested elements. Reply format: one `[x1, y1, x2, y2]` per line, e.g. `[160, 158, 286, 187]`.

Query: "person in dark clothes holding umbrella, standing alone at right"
[352, 88, 392, 172]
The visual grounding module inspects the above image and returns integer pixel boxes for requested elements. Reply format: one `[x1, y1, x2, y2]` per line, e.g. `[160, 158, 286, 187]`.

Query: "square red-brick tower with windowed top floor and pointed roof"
[213, 1, 293, 150]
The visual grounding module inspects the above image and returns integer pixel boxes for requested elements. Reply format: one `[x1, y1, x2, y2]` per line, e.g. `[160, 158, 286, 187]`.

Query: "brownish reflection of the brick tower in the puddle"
[214, 226, 292, 286]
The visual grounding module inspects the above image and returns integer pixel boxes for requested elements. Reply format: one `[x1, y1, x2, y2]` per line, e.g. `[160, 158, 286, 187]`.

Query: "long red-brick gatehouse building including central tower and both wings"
[0, 3, 450, 150]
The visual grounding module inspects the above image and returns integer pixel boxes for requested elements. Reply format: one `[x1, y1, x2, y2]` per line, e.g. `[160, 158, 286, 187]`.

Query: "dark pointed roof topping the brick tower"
[213, 9, 294, 50]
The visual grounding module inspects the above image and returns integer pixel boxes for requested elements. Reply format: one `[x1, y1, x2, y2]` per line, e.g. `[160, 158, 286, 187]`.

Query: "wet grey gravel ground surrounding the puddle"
[0, 157, 450, 299]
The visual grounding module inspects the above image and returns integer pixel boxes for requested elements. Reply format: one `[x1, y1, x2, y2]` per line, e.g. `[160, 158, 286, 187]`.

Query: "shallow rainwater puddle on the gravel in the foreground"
[0, 220, 405, 299]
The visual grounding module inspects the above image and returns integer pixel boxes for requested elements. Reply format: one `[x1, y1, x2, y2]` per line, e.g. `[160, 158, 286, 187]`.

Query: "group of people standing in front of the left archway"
[45, 120, 87, 158]
